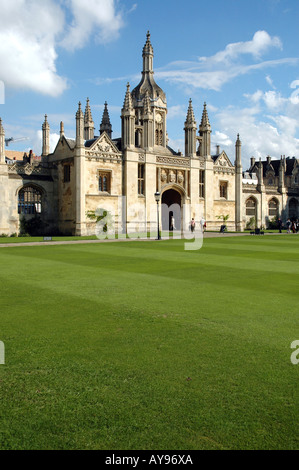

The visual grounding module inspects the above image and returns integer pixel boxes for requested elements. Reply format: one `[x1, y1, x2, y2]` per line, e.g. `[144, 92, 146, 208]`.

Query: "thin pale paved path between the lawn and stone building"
[0, 232, 258, 248]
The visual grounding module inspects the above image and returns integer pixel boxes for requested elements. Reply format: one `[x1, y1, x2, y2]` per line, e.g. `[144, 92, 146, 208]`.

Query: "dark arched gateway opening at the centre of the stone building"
[162, 188, 182, 231]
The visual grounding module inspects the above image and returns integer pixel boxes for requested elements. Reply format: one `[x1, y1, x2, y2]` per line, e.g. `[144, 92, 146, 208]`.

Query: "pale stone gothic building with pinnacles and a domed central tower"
[0, 33, 299, 235]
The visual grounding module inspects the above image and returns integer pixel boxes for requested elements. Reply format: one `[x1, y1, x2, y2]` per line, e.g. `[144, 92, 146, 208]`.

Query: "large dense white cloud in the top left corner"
[0, 0, 67, 96]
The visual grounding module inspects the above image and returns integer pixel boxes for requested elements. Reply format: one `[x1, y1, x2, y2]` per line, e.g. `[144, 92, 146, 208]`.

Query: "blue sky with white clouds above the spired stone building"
[0, 0, 299, 169]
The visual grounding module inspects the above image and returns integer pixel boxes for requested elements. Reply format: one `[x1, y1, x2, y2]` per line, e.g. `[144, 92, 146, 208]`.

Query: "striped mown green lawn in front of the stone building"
[0, 235, 299, 450]
